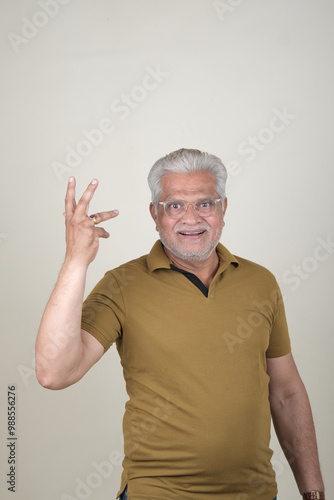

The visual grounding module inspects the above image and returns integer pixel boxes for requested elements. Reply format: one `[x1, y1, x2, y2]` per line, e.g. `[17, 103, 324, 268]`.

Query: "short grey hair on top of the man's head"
[148, 148, 227, 207]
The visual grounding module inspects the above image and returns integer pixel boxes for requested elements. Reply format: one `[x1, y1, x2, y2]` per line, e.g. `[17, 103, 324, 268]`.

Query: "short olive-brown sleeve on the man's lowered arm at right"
[266, 285, 291, 358]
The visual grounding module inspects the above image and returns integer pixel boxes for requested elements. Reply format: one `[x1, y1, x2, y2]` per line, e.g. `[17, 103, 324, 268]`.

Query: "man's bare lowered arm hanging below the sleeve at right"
[267, 354, 324, 494]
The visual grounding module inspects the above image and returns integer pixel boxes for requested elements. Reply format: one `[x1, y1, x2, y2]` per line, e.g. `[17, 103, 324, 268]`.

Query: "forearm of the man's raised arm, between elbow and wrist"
[36, 260, 87, 388]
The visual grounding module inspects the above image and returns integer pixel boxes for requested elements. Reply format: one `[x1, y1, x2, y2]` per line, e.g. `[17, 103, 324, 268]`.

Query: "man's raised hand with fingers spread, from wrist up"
[64, 177, 118, 266]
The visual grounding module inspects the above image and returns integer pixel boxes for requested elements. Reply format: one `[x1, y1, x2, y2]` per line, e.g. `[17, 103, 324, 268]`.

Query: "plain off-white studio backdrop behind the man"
[0, 0, 334, 500]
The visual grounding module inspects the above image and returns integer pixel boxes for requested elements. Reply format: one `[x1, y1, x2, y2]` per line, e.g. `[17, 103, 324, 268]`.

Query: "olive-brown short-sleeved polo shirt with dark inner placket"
[82, 241, 290, 500]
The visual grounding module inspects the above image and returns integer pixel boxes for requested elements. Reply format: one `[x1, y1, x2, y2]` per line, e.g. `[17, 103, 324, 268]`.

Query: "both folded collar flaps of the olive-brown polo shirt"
[147, 240, 239, 274]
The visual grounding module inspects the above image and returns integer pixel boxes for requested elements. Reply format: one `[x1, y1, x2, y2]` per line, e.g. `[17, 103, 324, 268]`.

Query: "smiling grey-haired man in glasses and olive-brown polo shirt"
[36, 149, 325, 500]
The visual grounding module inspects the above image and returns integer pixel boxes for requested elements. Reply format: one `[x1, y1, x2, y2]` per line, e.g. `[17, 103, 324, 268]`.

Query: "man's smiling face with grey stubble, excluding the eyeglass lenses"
[150, 172, 227, 262]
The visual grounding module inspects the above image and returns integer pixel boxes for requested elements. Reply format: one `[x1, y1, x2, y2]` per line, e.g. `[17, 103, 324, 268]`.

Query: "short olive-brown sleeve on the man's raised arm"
[81, 271, 125, 352]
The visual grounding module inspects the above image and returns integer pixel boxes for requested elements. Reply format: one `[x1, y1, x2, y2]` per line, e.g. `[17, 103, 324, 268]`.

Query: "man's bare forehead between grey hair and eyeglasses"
[161, 172, 218, 200]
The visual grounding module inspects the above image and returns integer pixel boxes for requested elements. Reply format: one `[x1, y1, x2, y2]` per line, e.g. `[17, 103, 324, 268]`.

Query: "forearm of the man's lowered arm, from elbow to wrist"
[271, 383, 324, 494]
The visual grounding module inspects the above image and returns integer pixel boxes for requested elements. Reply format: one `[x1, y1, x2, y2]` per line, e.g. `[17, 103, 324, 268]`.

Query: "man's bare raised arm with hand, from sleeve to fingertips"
[36, 177, 118, 389]
